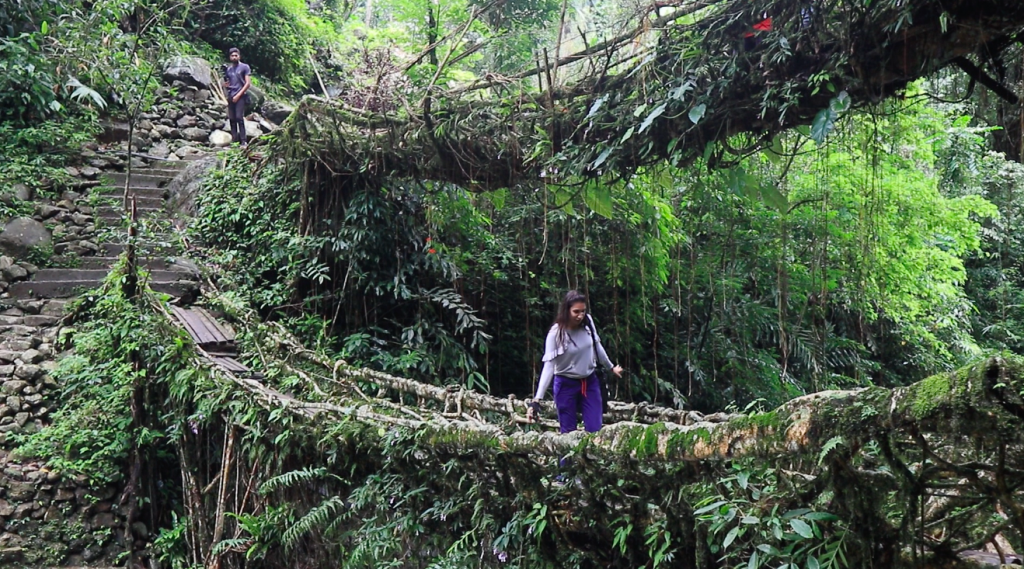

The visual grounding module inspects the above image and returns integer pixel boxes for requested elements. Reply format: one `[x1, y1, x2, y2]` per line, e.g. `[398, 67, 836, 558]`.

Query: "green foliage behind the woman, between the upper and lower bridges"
[197, 96, 996, 409]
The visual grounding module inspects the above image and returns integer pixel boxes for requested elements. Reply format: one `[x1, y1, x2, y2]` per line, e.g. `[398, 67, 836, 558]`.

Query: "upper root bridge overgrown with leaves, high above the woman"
[276, 0, 1024, 197]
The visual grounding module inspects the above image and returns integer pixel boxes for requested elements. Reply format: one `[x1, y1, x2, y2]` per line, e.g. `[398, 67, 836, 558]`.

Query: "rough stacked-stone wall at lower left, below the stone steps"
[0, 299, 130, 568]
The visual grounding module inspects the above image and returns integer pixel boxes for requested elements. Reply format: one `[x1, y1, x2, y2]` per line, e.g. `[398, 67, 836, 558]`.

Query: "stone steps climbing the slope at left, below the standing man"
[8, 161, 199, 300]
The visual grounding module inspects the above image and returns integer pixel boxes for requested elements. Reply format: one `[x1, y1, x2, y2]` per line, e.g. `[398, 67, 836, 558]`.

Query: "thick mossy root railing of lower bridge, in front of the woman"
[239, 356, 1024, 466]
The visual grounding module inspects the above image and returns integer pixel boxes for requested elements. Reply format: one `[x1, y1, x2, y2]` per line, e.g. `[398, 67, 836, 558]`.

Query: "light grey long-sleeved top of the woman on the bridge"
[534, 314, 614, 399]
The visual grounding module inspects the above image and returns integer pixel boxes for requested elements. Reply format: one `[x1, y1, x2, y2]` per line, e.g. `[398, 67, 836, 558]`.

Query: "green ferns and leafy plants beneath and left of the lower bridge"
[12, 255, 1016, 569]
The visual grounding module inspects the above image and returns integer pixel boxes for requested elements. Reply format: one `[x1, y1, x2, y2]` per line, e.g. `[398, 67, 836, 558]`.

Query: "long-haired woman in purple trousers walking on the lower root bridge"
[527, 291, 623, 433]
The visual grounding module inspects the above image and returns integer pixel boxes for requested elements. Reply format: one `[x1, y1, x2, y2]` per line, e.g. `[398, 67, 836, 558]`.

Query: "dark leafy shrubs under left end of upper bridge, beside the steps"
[193, 159, 489, 390]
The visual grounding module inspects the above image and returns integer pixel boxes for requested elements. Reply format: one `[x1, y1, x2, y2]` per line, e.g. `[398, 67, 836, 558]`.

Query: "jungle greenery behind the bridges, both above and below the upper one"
[8, 0, 1021, 410]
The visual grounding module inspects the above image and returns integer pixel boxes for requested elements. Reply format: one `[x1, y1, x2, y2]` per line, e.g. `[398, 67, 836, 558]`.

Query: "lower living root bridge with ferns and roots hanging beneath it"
[157, 286, 1024, 569]
